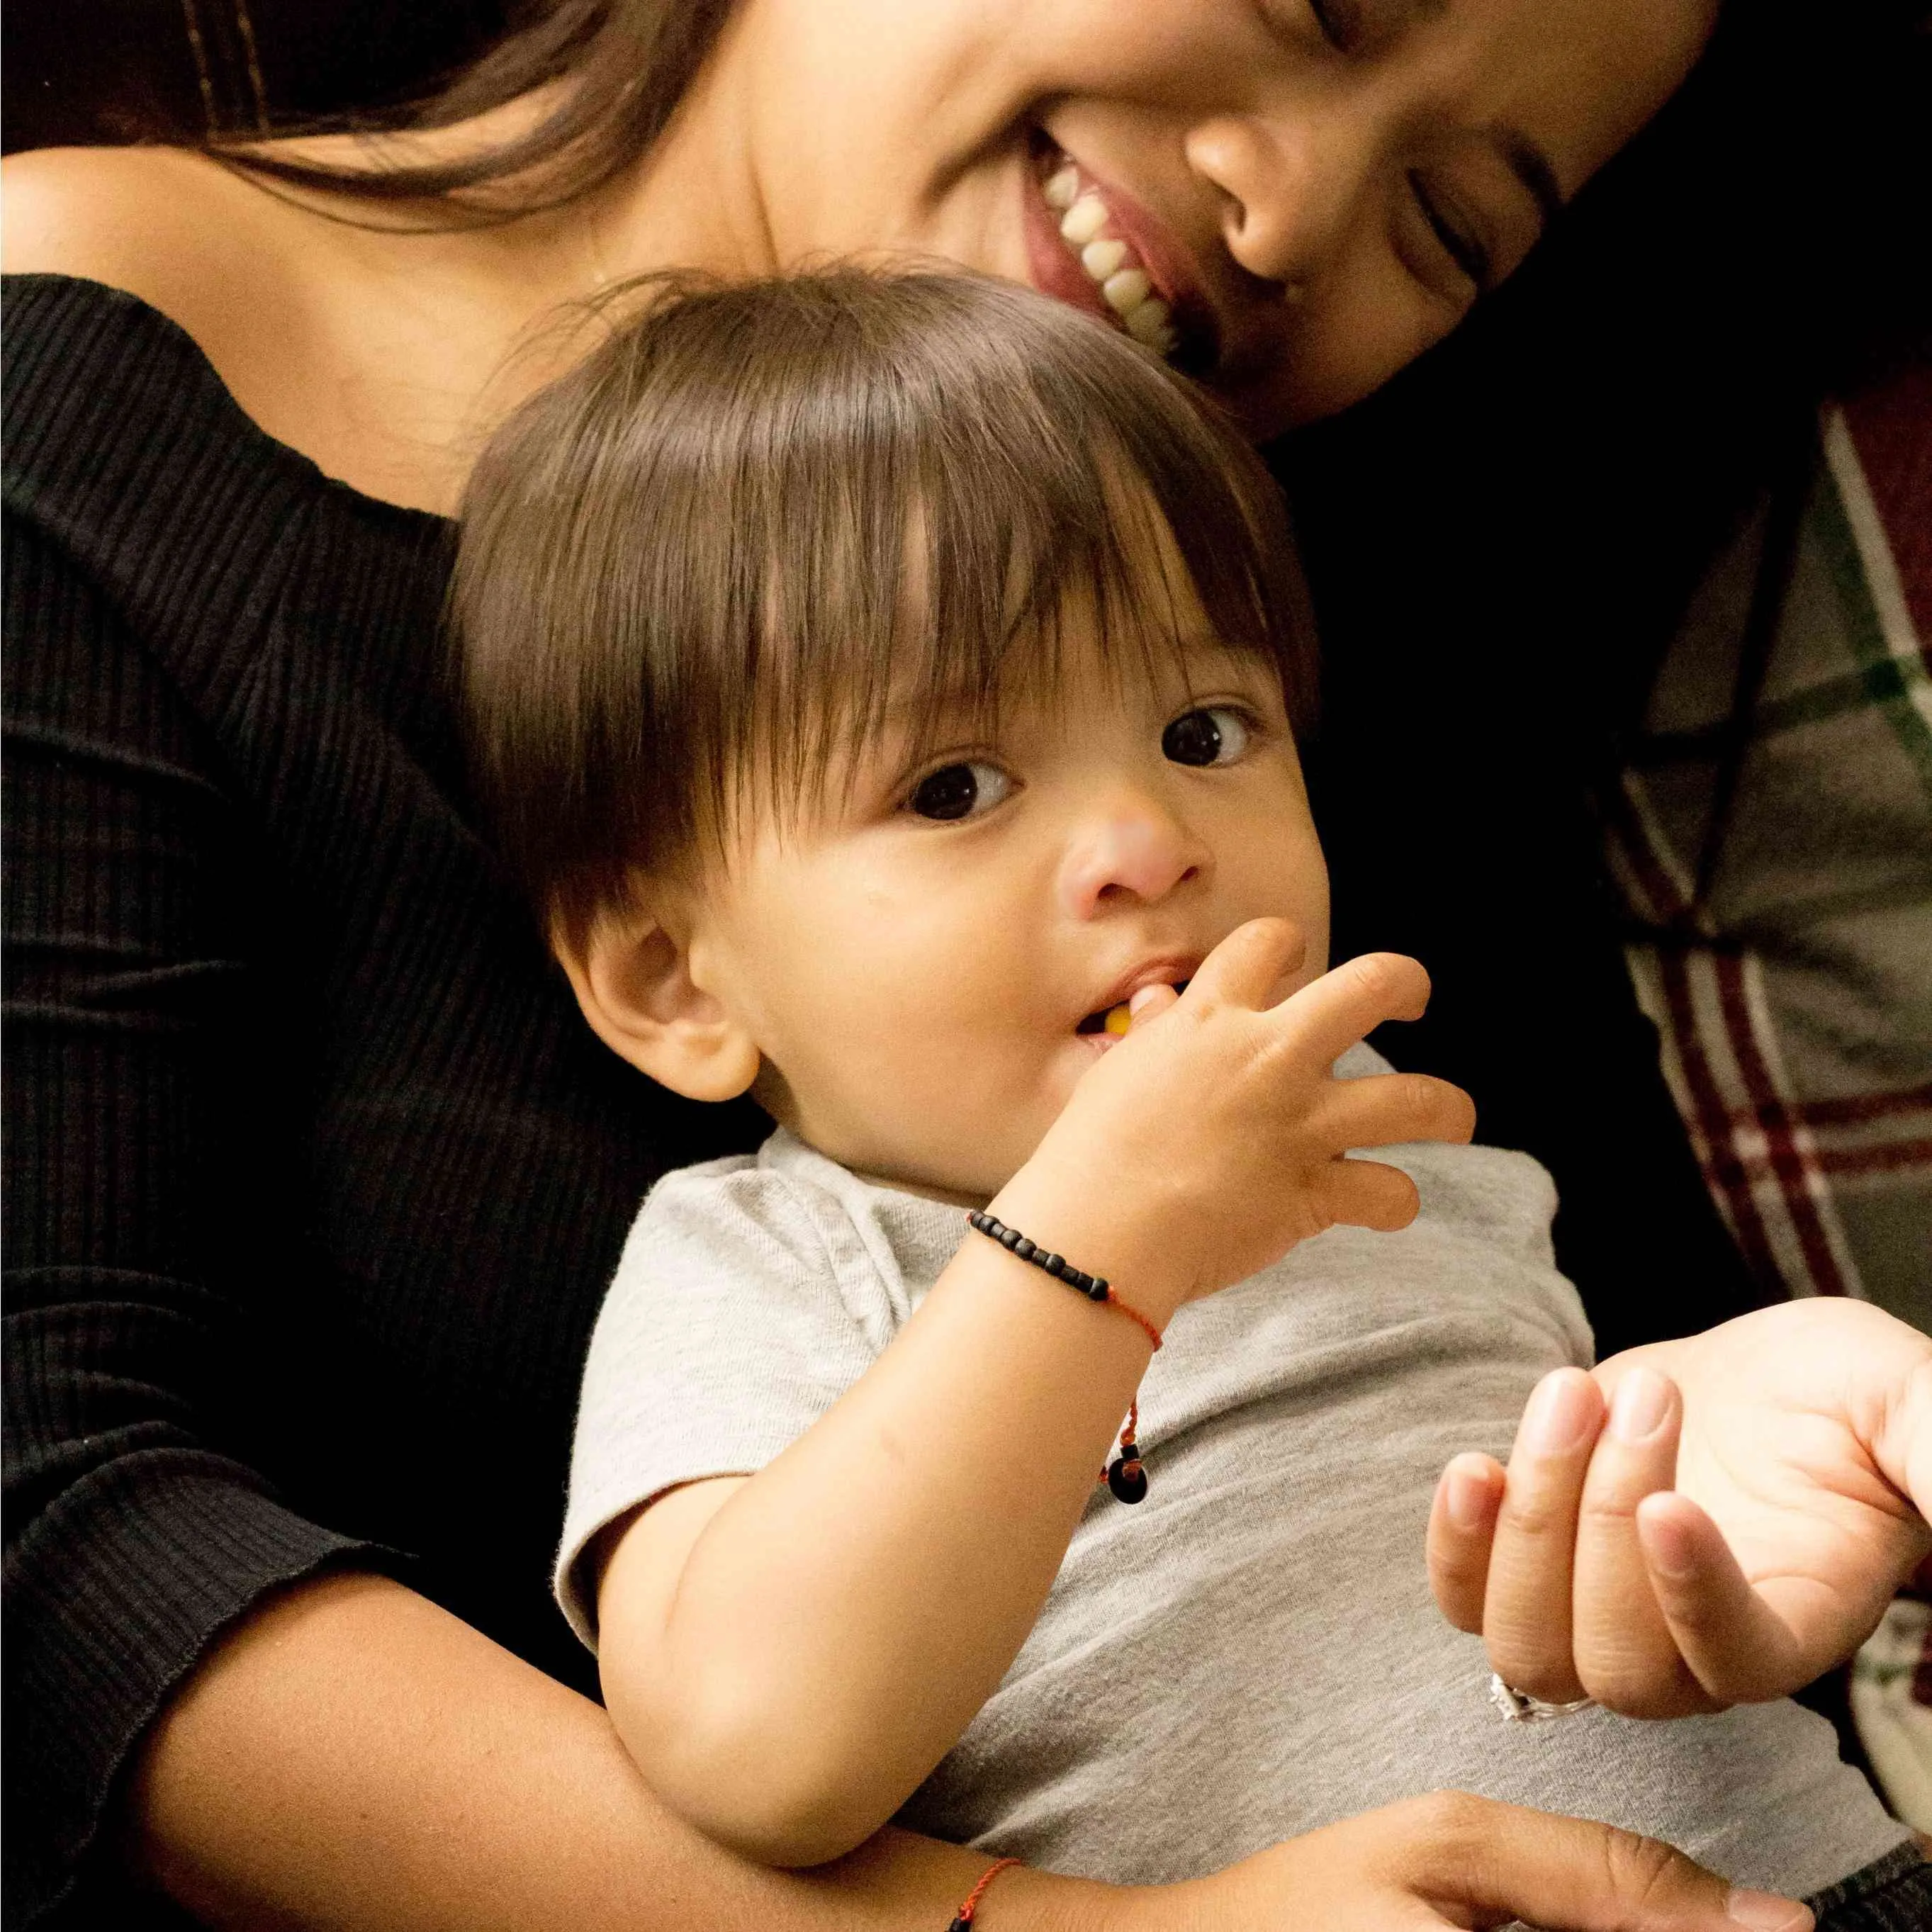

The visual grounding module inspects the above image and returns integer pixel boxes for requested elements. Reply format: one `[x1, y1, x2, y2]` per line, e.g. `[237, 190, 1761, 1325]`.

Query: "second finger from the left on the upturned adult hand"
[1482, 1368, 1604, 1704]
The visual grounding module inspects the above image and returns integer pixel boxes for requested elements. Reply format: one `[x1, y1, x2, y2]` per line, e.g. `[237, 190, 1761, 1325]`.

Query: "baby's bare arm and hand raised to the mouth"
[597, 921, 1472, 1865]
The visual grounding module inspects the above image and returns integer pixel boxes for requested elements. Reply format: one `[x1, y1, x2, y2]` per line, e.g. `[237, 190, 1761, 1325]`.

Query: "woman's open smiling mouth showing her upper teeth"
[1020, 137, 1213, 363]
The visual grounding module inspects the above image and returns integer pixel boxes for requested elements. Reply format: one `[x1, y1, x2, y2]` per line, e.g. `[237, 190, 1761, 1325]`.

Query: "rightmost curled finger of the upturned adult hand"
[1636, 1490, 1837, 1710]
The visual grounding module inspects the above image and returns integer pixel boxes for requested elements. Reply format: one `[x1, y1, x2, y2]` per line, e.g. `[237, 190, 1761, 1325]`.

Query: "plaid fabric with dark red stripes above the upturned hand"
[1605, 369, 1932, 1329]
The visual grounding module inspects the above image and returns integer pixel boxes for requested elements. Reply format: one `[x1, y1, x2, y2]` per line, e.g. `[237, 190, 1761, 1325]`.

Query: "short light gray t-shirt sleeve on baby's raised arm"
[556, 1155, 894, 1648]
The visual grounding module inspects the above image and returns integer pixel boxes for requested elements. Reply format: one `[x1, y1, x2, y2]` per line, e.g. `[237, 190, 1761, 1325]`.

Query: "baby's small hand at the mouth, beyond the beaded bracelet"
[993, 920, 1476, 1314]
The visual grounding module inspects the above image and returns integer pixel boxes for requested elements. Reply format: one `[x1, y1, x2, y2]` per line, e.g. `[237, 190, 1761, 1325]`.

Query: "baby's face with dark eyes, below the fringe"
[690, 622, 1327, 1202]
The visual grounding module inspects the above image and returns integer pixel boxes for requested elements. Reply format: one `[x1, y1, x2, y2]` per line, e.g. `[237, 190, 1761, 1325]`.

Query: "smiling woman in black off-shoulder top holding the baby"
[8, 0, 1870, 1928]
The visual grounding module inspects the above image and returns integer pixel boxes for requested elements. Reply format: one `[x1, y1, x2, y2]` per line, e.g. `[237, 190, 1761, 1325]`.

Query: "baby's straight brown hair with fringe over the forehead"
[450, 269, 1314, 931]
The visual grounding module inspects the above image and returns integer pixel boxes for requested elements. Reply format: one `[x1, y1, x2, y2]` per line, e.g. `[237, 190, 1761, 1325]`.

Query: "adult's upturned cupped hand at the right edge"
[1430, 1301, 1932, 1717]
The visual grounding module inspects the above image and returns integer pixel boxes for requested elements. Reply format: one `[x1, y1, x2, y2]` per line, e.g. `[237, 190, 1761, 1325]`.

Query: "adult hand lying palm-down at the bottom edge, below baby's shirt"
[1107, 1791, 1812, 1932]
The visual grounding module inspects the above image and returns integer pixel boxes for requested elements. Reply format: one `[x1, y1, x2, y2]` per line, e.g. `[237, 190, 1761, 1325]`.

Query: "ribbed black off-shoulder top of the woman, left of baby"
[6, 276, 759, 1924]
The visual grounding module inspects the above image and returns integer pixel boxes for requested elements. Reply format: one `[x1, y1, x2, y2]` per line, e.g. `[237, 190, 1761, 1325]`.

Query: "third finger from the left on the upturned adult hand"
[1571, 1364, 1716, 1717]
